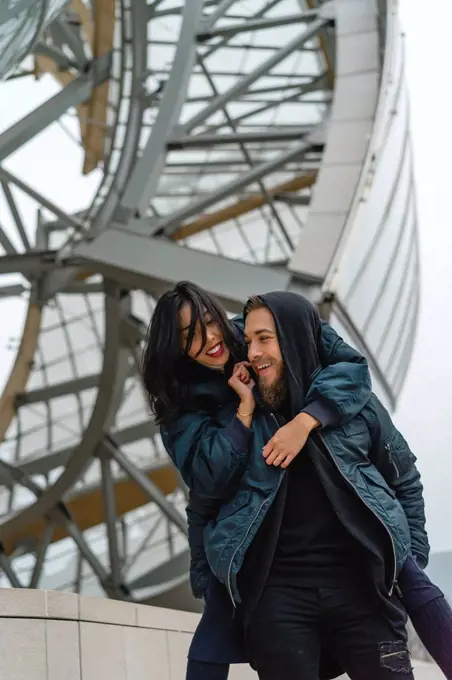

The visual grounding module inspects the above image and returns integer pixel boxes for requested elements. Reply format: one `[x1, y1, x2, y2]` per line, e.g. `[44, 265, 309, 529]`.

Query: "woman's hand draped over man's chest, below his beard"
[262, 413, 320, 468]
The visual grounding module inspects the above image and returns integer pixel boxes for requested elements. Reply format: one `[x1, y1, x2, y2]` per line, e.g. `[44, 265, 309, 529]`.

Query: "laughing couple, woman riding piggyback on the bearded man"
[143, 282, 452, 680]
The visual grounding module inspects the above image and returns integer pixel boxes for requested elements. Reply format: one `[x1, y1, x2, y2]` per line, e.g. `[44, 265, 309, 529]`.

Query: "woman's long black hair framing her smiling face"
[141, 281, 238, 423]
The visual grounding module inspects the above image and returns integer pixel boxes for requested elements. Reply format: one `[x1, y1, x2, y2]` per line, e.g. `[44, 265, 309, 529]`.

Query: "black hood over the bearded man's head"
[251, 292, 321, 415]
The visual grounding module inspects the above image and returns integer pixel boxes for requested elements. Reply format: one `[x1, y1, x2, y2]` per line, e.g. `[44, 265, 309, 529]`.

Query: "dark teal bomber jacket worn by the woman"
[161, 306, 372, 597]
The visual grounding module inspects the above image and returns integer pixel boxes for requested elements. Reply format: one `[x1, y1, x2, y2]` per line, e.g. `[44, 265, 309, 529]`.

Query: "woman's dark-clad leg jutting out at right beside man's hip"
[399, 557, 452, 680]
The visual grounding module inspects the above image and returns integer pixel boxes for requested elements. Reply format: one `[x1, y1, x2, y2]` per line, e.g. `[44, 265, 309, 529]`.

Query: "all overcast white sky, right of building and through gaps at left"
[0, 0, 452, 550]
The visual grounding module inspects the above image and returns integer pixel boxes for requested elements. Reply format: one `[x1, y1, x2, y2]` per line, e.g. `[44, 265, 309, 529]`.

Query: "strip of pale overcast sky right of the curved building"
[396, 0, 452, 550]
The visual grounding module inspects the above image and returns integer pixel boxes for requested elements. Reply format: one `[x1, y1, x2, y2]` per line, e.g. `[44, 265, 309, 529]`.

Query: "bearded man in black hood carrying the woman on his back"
[237, 293, 428, 680]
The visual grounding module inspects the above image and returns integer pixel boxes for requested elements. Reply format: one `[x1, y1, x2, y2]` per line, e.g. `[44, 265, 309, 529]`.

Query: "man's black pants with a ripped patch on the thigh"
[248, 585, 414, 680]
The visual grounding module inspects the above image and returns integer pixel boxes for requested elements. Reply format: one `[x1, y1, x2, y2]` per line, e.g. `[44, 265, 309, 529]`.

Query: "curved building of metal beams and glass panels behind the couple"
[0, 0, 418, 608]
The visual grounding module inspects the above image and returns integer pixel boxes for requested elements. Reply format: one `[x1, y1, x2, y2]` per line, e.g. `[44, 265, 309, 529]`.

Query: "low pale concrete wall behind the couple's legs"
[0, 589, 441, 680]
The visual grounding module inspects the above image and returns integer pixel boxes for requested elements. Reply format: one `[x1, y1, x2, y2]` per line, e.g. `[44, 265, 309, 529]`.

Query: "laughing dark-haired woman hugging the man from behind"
[143, 283, 450, 680]
